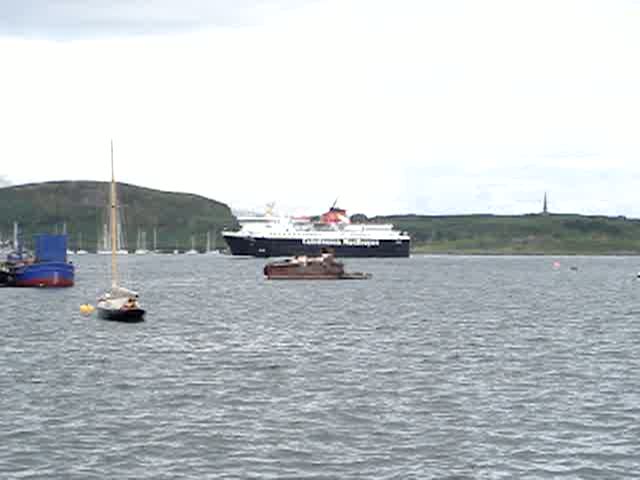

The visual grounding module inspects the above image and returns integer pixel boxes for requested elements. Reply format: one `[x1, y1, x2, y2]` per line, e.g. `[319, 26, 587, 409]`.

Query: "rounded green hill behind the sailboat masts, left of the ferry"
[0, 181, 237, 251]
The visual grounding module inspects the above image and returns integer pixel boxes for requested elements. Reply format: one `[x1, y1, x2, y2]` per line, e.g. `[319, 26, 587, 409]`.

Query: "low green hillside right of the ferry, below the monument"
[372, 214, 640, 254]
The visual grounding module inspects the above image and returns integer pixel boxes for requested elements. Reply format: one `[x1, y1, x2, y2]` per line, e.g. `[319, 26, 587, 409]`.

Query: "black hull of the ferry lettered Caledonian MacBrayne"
[224, 235, 410, 257]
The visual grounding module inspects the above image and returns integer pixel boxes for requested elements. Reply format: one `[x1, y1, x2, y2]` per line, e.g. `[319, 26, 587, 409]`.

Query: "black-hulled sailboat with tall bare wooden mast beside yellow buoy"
[97, 142, 145, 322]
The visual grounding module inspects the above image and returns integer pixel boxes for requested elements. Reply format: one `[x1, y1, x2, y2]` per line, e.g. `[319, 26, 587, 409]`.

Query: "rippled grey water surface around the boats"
[0, 255, 640, 479]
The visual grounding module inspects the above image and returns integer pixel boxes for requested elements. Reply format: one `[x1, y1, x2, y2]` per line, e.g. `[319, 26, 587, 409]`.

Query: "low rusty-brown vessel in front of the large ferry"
[264, 252, 372, 280]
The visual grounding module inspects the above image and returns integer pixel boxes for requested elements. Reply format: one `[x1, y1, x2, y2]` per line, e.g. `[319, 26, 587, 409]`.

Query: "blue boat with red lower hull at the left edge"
[4, 231, 75, 287]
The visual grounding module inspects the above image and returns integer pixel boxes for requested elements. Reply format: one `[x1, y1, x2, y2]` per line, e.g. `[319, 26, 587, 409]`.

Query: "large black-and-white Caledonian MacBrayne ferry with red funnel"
[222, 206, 411, 257]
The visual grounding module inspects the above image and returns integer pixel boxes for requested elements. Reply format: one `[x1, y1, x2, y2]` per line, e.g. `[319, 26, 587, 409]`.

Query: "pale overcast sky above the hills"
[0, 0, 640, 217]
